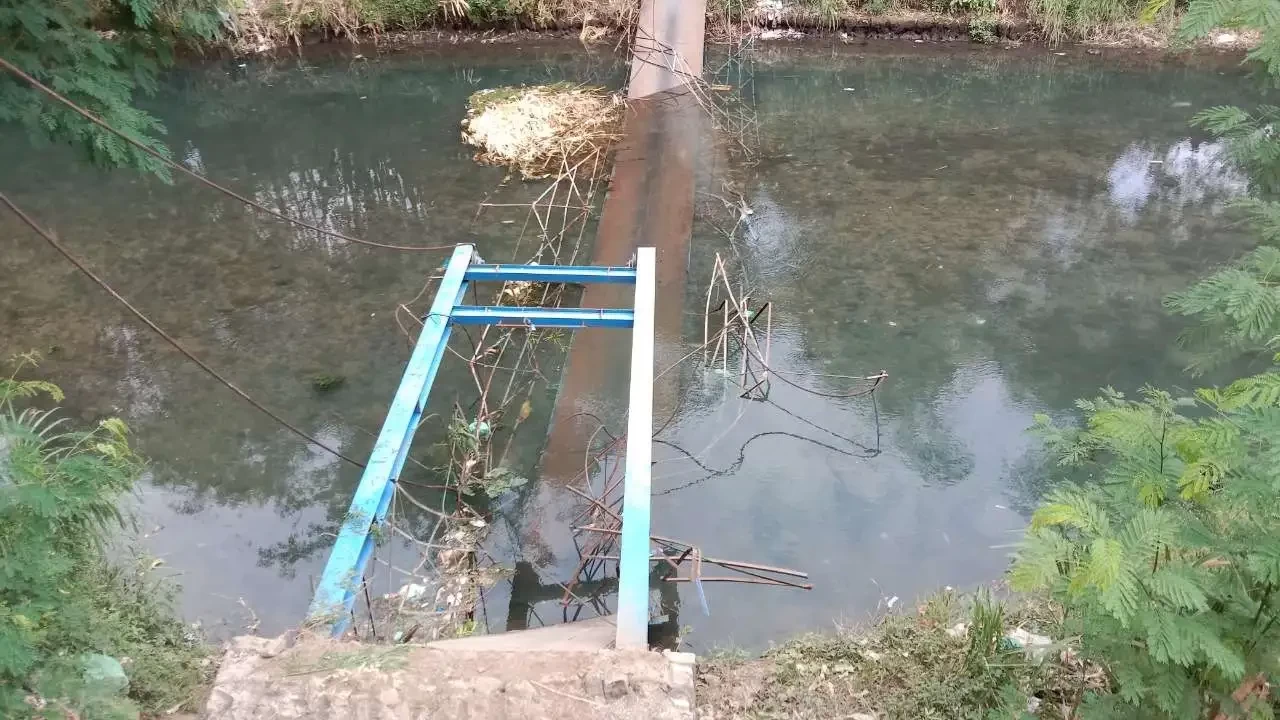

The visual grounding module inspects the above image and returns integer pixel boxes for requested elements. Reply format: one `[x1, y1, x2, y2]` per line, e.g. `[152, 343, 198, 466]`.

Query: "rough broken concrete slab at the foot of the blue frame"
[204, 637, 694, 720]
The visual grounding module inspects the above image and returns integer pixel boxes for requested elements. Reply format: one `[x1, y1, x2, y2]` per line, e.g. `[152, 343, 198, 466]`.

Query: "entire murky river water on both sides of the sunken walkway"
[0, 41, 1253, 640]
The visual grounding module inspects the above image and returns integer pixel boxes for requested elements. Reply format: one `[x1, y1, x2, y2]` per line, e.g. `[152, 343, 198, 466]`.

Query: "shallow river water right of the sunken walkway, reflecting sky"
[653, 51, 1249, 651]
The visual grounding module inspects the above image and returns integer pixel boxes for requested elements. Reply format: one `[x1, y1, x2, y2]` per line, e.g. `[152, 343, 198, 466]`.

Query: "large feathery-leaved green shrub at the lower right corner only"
[1011, 386, 1280, 719]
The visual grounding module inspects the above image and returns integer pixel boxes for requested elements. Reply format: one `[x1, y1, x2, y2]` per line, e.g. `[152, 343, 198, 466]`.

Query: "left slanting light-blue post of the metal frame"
[307, 245, 475, 637]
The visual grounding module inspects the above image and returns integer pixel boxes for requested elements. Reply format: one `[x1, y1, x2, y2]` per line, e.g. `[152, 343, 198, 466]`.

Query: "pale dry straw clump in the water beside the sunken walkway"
[462, 83, 625, 179]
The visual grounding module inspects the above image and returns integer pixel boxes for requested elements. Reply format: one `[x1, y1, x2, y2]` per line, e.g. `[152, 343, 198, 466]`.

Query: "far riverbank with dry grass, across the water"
[217, 0, 1258, 54]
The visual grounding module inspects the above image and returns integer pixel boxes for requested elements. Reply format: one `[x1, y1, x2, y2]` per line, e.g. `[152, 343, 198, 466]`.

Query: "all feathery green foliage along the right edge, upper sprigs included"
[1011, 0, 1280, 719]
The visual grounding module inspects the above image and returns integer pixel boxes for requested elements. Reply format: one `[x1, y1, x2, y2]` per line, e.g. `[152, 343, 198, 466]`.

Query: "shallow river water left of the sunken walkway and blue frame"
[0, 45, 621, 633]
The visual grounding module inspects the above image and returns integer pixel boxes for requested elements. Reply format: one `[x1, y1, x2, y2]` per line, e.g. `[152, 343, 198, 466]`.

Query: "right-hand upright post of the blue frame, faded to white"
[614, 247, 657, 650]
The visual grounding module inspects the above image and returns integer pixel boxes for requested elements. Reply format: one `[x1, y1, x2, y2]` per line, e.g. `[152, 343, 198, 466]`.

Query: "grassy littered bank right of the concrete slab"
[698, 591, 1106, 720]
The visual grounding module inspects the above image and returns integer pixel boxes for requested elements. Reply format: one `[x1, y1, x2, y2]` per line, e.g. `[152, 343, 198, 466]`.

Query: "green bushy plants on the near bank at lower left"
[0, 356, 207, 719]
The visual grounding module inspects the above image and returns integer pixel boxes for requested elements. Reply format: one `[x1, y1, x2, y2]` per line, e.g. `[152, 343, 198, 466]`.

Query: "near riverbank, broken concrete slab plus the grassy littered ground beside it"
[194, 588, 1075, 720]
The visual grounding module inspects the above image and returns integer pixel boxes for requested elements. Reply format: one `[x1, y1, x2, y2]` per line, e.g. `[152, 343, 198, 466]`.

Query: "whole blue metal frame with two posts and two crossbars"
[307, 245, 655, 647]
